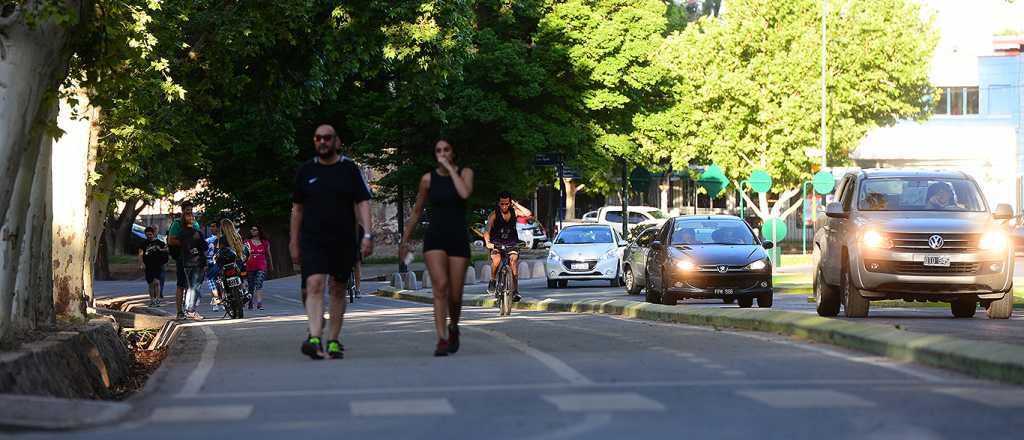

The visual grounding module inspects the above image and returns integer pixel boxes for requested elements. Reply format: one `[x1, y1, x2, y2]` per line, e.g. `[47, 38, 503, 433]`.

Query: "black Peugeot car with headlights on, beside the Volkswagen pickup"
[644, 216, 774, 308]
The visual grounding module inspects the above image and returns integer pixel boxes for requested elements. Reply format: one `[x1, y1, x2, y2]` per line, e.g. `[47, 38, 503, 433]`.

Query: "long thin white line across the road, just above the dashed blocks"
[175, 379, 975, 400]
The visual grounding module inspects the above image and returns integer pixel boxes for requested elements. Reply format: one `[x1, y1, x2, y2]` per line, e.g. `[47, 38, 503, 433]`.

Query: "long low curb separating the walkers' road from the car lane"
[376, 288, 1024, 384]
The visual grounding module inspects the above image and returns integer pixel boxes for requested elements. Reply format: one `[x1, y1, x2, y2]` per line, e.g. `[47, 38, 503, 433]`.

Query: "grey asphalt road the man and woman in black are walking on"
[37, 278, 1024, 440]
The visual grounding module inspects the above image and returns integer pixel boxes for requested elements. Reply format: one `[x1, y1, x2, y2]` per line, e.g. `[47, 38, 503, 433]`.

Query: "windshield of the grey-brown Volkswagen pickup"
[857, 177, 985, 212]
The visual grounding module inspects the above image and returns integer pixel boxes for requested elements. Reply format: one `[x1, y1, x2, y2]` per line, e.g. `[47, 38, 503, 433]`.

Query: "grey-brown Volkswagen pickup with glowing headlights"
[813, 169, 1014, 319]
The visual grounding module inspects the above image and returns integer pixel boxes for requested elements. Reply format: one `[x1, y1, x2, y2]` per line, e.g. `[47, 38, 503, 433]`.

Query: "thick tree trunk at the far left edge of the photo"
[0, 0, 82, 340]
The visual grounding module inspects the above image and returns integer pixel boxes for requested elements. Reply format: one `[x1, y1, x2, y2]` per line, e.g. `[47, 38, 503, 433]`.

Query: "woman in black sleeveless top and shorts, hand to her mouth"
[398, 139, 473, 356]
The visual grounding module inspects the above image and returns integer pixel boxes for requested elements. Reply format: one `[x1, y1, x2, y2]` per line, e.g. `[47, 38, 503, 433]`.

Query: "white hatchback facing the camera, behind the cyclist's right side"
[544, 224, 626, 289]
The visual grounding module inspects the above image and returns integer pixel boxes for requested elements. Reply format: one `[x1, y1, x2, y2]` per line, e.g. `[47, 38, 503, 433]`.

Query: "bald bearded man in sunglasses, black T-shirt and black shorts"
[289, 125, 373, 359]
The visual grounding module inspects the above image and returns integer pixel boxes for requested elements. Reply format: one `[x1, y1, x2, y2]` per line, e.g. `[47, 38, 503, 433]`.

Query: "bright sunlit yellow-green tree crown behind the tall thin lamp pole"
[637, 0, 937, 190]
